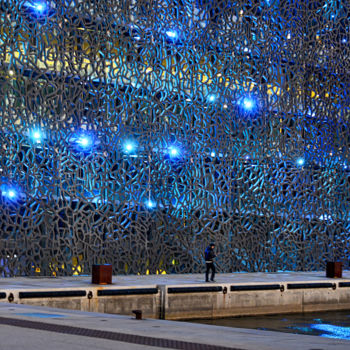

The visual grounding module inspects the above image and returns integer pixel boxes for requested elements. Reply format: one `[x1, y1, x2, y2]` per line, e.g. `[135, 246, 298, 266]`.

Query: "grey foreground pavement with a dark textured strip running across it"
[0, 303, 350, 350]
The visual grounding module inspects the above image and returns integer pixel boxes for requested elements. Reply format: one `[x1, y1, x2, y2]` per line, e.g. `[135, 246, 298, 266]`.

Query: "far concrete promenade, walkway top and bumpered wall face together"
[0, 271, 350, 320]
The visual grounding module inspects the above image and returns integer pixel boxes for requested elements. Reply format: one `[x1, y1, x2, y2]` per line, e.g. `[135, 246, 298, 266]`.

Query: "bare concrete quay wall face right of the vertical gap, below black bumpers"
[164, 284, 350, 320]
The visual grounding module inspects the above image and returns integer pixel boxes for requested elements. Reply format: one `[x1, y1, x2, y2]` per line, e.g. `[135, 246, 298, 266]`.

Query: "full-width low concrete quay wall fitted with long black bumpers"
[0, 280, 350, 320]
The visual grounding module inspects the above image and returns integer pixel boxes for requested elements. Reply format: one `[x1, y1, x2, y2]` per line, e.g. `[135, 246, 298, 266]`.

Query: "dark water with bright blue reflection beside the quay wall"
[193, 311, 350, 340]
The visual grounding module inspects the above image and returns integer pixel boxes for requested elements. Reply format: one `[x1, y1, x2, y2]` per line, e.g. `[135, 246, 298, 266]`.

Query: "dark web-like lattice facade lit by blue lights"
[0, 0, 350, 276]
